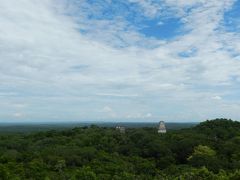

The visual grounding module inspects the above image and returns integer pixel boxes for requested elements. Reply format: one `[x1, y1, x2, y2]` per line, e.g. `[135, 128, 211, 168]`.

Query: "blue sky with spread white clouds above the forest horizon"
[0, 0, 240, 122]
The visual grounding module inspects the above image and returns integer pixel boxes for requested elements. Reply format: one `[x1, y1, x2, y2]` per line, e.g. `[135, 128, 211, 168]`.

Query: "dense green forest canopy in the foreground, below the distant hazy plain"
[0, 119, 240, 180]
